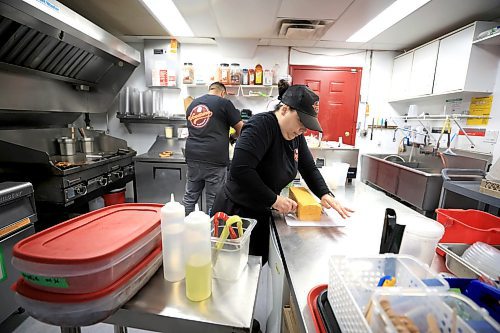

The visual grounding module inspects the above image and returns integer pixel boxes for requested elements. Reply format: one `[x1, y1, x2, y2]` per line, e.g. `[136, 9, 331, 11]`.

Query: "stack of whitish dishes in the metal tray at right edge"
[462, 242, 500, 280]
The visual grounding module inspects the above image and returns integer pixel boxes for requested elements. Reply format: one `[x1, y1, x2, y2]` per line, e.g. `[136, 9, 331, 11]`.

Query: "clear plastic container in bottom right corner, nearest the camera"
[368, 291, 500, 333]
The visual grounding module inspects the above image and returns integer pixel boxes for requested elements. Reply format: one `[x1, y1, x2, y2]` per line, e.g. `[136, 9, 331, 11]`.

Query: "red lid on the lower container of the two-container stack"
[11, 247, 161, 303]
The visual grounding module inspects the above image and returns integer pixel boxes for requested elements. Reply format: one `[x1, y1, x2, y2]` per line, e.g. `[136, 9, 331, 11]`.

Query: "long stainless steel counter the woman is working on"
[273, 181, 437, 332]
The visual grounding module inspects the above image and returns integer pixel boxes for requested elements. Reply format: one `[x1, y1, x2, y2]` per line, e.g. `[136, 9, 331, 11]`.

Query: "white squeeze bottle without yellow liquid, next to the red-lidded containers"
[161, 193, 186, 282]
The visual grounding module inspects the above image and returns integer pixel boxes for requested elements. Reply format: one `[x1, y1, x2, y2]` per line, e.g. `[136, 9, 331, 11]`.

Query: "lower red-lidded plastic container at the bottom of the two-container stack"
[13, 247, 161, 327]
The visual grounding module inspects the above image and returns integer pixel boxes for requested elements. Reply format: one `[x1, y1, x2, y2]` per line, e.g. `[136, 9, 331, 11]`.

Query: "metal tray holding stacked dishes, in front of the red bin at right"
[438, 243, 500, 287]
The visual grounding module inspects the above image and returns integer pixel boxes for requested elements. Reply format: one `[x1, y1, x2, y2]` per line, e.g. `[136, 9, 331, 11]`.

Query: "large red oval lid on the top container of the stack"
[13, 203, 162, 265]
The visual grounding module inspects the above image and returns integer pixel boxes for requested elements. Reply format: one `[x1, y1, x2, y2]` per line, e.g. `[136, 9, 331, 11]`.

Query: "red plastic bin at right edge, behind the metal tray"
[436, 208, 500, 245]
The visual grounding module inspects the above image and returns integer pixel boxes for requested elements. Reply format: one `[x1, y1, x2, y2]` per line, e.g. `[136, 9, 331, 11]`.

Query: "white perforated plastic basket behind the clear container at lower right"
[328, 254, 449, 332]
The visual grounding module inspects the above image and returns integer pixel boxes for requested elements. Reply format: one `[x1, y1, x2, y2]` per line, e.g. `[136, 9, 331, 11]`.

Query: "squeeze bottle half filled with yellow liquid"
[184, 205, 212, 302]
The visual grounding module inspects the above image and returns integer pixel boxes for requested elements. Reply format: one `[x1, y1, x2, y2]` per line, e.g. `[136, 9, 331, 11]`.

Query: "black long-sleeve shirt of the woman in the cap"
[224, 112, 330, 212]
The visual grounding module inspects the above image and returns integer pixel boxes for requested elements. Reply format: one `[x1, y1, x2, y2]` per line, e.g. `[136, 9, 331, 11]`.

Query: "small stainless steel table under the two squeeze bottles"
[106, 256, 262, 333]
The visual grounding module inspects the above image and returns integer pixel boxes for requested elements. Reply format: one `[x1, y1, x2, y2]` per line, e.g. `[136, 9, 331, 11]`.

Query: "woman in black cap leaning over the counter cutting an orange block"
[212, 85, 352, 263]
